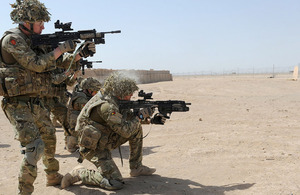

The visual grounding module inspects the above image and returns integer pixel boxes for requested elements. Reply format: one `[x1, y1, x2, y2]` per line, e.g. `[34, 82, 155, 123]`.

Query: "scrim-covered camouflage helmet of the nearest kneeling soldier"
[103, 72, 139, 98]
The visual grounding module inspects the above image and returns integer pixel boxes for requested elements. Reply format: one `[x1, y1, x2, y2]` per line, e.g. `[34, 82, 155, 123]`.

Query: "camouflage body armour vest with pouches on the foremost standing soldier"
[0, 28, 51, 97]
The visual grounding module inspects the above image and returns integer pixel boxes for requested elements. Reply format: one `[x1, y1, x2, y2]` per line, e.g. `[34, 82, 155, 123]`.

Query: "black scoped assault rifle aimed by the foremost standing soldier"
[31, 20, 121, 49]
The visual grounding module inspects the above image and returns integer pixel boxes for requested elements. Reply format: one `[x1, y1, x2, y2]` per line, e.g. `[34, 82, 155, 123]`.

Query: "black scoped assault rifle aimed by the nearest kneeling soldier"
[119, 90, 191, 118]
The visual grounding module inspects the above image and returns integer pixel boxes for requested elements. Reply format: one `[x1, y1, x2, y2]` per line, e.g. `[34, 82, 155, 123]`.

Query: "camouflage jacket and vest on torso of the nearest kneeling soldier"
[75, 91, 140, 149]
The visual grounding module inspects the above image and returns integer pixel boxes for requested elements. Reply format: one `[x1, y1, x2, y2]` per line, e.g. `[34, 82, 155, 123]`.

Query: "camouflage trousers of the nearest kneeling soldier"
[80, 126, 143, 184]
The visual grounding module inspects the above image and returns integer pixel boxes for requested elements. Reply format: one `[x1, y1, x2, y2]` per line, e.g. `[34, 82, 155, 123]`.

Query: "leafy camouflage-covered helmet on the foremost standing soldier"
[10, 0, 51, 23]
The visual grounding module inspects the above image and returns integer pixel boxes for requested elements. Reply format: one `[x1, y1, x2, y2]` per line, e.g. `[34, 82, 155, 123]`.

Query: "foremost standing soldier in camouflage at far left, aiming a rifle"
[0, 0, 88, 195]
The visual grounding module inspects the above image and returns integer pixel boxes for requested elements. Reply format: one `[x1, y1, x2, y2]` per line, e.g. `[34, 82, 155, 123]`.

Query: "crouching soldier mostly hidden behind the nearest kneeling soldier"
[66, 78, 101, 153]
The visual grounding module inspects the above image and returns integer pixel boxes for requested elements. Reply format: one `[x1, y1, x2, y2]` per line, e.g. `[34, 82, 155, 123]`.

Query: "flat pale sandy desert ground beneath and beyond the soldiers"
[0, 75, 300, 195]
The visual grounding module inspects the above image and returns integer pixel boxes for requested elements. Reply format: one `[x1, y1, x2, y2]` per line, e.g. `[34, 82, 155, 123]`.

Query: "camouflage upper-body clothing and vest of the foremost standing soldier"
[0, 28, 78, 97]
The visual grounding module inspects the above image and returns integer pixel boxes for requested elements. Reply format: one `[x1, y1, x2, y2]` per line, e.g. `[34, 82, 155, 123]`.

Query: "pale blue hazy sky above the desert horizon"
[0, 0, 300, 73]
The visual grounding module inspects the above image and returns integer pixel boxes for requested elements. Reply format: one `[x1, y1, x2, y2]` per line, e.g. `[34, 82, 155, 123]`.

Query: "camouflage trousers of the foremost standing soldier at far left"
[2, 96, 59, 194]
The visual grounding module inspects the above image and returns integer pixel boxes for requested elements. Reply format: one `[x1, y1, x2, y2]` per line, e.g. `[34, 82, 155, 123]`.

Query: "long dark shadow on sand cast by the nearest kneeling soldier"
[65, 175, 255, 195]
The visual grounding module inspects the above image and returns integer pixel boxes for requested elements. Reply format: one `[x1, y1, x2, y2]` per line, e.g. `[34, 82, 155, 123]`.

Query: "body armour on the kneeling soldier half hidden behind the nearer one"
[68, 91, 89, 129]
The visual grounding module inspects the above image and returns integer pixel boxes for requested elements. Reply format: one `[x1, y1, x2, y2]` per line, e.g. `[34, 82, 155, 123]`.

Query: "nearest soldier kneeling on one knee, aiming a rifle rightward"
[61, 73, 165, 190]
